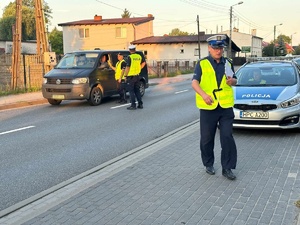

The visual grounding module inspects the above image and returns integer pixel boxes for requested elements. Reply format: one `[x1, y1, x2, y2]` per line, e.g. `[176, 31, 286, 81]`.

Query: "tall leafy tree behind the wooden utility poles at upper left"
[0, 0, 52, 40]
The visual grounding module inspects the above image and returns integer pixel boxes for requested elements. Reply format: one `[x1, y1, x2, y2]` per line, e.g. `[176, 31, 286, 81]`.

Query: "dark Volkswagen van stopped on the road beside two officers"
[42, 50, 149, 106]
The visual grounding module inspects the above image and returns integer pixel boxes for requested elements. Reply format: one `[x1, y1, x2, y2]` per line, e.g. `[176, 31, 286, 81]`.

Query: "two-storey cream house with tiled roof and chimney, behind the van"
[58, 14, 154, 53]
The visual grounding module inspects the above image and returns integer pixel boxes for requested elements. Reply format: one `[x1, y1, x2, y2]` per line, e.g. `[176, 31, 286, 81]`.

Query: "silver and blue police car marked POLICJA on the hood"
[233, 60, 300, 129]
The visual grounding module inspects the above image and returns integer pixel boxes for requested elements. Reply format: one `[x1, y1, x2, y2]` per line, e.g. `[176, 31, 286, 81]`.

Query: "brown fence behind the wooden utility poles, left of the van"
[0, 54, 44, 91]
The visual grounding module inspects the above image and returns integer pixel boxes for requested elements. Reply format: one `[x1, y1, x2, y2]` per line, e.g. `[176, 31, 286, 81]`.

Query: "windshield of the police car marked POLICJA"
[236, 64, 297, 86]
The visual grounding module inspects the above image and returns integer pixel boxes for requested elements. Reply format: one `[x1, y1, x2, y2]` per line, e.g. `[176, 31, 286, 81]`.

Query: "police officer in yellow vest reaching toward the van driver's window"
[108, 52, 127, 103]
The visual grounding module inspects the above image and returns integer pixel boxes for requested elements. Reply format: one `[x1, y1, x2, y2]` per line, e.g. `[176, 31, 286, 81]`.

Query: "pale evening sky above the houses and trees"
[0, 0, 300, 45]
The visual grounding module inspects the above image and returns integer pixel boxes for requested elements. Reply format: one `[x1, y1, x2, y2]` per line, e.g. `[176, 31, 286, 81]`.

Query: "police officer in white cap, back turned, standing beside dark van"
[125, 45, 146, 110]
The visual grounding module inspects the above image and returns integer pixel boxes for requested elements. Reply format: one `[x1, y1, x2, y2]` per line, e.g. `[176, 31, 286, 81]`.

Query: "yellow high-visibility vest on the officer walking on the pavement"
[196, 59, 234, 110]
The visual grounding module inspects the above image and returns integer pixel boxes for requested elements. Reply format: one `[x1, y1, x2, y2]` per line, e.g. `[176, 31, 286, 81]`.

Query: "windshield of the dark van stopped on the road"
[56, 53, 98, 69]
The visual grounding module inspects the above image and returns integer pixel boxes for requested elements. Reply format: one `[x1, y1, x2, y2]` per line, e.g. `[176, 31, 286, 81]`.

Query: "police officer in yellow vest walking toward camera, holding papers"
[192, 35, 237, 180]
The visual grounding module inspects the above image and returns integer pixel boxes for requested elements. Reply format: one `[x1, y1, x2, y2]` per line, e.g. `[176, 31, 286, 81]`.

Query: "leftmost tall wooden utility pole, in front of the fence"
[11, 0, 22, 90]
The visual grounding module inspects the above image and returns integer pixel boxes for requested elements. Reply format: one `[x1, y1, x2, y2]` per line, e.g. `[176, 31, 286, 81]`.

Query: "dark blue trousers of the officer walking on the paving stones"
[200, 106, 237, 169]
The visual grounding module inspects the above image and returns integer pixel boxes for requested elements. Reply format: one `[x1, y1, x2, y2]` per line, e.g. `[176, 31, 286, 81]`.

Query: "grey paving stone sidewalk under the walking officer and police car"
[0, 121, 300, 225]
